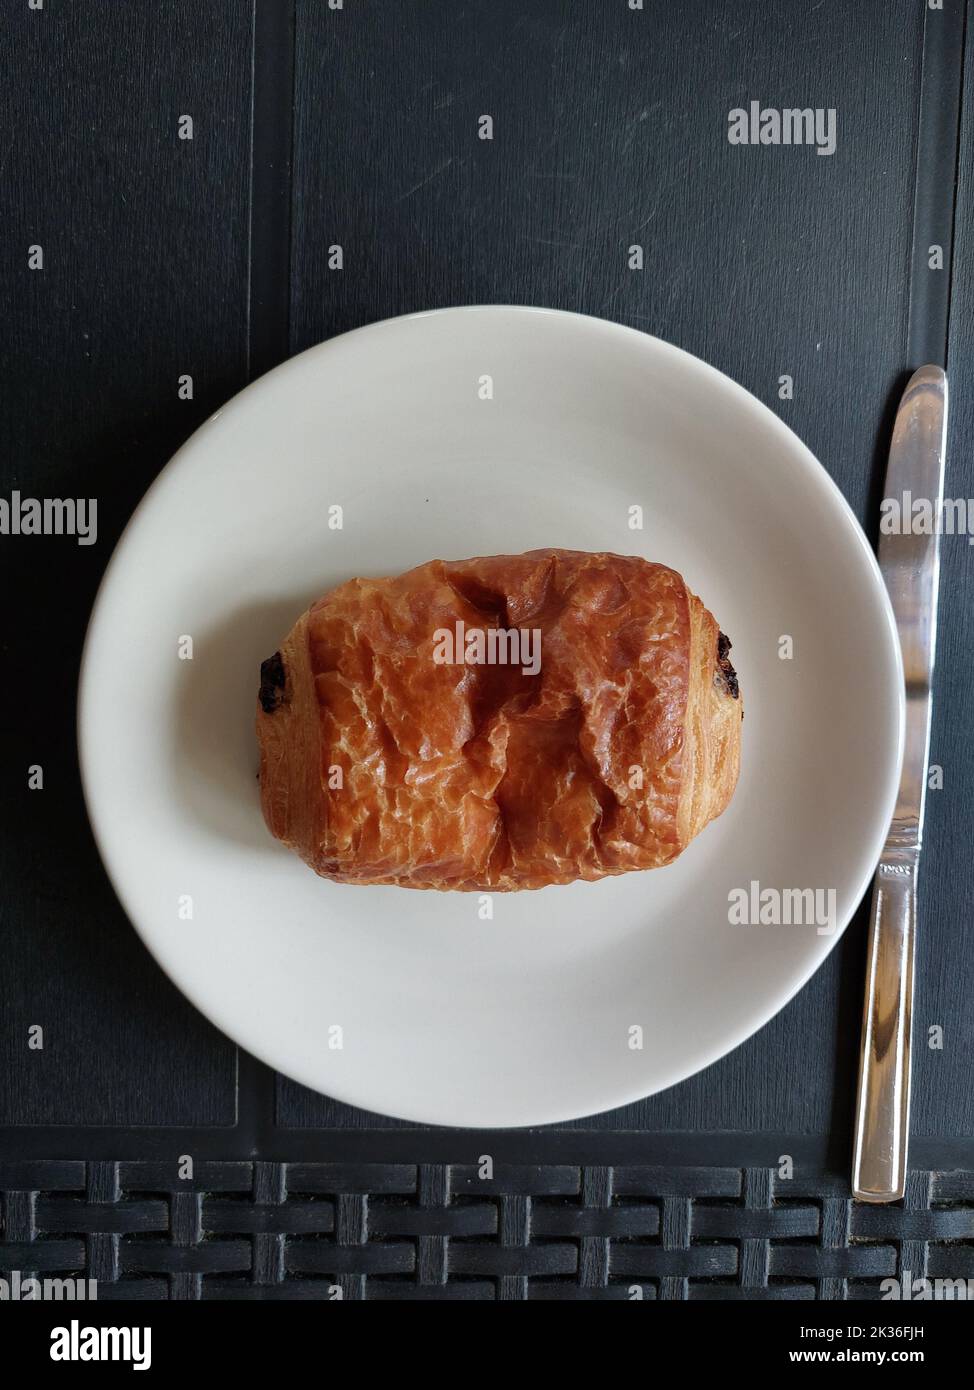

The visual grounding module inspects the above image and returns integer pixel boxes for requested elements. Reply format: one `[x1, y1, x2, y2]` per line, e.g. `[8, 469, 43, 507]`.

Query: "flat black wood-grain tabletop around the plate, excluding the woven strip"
[0, 0, 974, 1206]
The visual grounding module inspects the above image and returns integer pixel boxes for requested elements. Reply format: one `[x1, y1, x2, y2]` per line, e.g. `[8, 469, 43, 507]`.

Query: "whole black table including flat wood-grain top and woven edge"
[0, 0, 974, 1298]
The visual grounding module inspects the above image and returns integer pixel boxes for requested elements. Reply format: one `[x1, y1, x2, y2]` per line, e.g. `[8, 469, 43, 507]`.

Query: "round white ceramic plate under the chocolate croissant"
[79, 307, 903, 1126]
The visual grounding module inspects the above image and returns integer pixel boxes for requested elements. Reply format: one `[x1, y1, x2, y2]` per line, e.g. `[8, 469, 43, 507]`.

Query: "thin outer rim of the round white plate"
[75, 304, 906, 1131]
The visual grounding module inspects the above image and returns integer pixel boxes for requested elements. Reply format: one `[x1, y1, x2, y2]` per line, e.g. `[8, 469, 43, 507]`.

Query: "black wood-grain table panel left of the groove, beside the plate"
[0, 0, 250, 1125]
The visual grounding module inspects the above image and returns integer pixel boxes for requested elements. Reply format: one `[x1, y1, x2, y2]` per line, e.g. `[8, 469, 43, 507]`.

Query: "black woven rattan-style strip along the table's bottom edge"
[0, 1161, 974, 1301]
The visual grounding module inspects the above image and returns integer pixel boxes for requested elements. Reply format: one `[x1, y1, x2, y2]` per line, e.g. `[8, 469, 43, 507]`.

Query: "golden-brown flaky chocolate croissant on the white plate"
[257, 550, 742, 892]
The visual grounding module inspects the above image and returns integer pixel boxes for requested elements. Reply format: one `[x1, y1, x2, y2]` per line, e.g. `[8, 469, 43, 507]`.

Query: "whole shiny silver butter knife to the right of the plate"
[852, 366, 948, 1202]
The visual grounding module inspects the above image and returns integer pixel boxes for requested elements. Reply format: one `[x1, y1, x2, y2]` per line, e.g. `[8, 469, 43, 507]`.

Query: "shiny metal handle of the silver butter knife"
[852, 855, 917, 1202]
